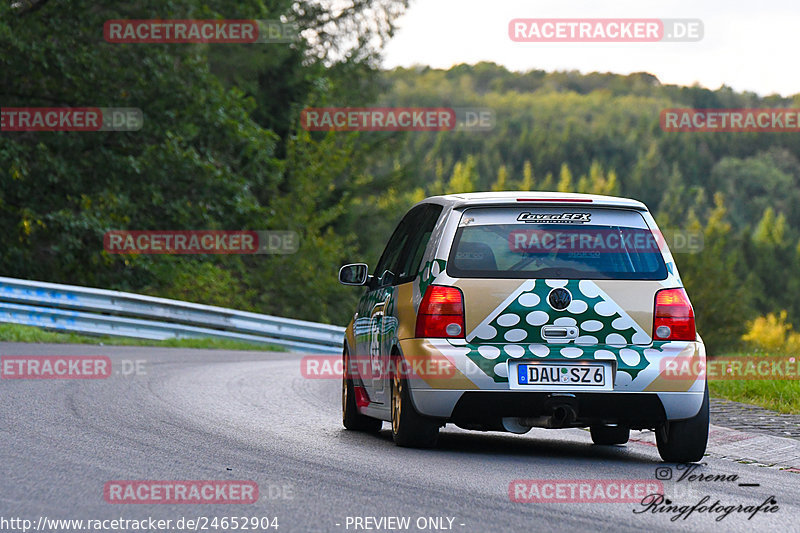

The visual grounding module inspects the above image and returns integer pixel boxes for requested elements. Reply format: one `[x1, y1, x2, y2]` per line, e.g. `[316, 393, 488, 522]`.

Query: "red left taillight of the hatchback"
[416, 285, 464, 338]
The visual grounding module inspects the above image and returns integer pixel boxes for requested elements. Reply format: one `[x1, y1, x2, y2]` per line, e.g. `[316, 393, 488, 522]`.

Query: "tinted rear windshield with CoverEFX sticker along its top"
[447, 208, 667, 280]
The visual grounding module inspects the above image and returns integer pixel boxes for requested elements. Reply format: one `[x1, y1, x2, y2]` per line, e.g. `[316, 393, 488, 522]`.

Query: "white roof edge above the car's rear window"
[420, 191, 647, 211]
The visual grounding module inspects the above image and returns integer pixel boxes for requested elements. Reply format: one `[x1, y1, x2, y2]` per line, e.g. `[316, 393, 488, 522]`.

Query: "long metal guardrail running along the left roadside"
[0, 277, 344, 353]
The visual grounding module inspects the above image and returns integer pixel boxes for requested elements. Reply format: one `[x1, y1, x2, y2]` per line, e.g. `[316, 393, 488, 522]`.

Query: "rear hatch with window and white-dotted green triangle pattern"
[447, 204, 669, 382]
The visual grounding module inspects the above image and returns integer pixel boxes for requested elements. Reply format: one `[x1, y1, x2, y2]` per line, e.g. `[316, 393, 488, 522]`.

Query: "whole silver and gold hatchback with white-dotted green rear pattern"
[339, 192, 709, 462]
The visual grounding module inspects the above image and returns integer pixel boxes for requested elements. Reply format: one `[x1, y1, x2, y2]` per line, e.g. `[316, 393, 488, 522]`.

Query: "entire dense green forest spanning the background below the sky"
[0, 0, 800, 350]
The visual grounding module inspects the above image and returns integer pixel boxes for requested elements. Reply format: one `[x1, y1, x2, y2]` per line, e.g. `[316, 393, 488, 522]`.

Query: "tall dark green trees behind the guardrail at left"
[0, 0, 406, 323]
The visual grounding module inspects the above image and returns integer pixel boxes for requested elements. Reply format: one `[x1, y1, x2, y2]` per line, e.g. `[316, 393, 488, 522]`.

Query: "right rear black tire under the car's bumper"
[656, 383, 709, 463]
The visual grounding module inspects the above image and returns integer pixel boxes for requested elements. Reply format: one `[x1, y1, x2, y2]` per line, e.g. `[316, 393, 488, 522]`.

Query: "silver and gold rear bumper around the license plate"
[400, 339, 705, 427]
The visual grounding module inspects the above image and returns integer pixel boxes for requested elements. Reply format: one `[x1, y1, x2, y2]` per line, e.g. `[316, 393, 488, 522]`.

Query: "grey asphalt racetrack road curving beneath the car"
[0, 343, 800, 532]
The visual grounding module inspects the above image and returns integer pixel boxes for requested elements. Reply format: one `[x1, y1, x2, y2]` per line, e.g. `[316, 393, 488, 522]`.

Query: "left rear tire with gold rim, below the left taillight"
[392, 356, 439, 448]
